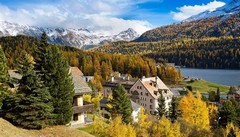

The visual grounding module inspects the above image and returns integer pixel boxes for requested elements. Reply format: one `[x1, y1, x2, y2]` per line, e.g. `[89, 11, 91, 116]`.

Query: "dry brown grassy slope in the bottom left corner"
[0, 118, 93, 137]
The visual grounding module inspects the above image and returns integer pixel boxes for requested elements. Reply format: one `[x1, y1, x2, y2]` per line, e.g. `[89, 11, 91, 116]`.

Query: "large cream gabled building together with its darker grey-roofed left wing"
[101, 75, 172, 117]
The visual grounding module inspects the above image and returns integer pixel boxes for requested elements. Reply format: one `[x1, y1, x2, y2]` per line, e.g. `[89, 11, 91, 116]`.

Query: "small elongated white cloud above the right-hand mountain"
[171, 0, 225, 21]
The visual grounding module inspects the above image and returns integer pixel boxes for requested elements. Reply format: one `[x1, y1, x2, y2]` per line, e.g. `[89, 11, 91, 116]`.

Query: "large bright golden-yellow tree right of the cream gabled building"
[179, 92, 209, 130]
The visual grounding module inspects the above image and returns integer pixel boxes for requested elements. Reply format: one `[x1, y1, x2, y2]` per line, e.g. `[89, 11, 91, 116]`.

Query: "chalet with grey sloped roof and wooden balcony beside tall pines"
[70, 67, 94, 125]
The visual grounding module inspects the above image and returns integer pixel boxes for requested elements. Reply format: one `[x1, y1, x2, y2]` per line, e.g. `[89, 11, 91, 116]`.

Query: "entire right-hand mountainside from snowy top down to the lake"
[93, 0, 240, 69]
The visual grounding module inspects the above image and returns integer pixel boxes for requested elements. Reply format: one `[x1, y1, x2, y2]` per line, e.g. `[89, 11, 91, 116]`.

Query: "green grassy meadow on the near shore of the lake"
[186, 80, 229, 94]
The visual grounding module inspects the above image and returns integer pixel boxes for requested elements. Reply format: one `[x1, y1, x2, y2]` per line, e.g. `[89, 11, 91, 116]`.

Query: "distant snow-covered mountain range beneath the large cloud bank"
[0, 21, 139, 49]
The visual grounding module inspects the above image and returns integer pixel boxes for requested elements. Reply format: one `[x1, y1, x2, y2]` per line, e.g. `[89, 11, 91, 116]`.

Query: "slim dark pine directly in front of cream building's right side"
[156, 93, 166, 119]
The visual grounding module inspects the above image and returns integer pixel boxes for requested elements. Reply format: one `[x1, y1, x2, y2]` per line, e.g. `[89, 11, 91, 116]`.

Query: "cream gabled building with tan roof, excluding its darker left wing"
[128, 77, 173, 114]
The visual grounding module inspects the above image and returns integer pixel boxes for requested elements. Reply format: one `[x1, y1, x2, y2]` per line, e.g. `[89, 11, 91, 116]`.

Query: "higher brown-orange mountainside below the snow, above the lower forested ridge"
[135, 13, 240, 42]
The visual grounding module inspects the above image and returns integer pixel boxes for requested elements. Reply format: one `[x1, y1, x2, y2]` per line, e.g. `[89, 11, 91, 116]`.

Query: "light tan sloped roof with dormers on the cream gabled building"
[140, 77, 173, 99]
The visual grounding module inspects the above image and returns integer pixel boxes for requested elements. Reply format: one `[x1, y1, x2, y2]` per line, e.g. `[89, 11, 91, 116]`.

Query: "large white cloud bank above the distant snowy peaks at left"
[0, 0, 154, 35]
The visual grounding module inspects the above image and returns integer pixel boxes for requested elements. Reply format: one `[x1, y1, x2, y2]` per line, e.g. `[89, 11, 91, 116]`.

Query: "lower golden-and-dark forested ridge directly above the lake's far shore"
[93, 37, 240, 69]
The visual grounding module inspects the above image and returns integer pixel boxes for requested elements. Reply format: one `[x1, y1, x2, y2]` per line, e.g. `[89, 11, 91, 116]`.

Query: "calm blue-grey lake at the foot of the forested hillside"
[181, 68, 240, 86]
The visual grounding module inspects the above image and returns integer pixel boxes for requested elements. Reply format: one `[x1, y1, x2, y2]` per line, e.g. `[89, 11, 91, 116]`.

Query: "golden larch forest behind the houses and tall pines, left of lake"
[0, 36, 180, 81]
